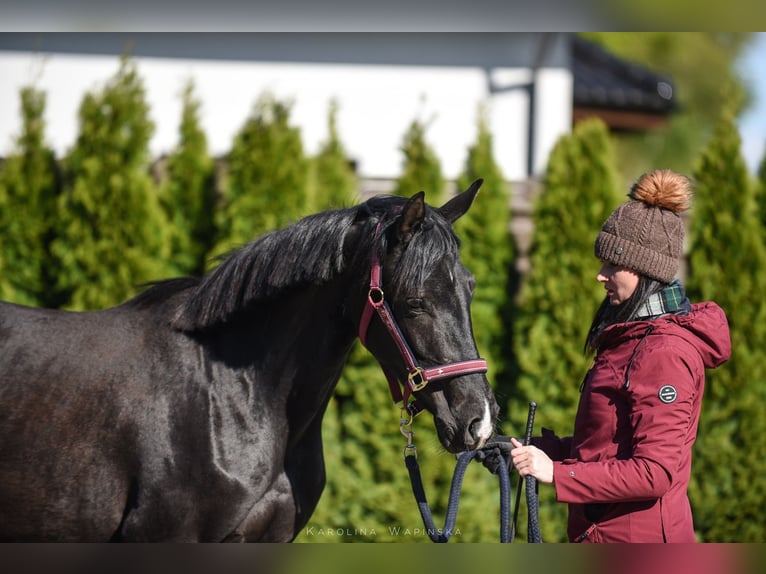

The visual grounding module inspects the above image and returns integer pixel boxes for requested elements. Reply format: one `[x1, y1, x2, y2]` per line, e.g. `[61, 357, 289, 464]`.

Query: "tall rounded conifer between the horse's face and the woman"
[509, 120, 619, 542]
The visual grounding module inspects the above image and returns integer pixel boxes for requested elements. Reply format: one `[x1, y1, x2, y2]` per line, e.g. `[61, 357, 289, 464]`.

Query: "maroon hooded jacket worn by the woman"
[533, 303, 731, 542]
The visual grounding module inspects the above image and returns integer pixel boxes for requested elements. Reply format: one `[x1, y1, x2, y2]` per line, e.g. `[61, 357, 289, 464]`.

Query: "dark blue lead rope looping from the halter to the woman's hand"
[399, 402, 542, 543]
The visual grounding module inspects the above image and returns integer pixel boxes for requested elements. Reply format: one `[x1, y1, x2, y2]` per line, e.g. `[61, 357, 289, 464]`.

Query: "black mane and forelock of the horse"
[132, 196, 458, 331]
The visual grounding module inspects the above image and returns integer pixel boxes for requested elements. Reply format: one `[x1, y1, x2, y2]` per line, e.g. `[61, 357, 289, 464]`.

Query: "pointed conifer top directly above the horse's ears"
[394, 120, 445, 205]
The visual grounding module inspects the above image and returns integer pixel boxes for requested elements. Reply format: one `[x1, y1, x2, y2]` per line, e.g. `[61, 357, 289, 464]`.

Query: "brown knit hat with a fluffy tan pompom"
[594, 169, 692, 283]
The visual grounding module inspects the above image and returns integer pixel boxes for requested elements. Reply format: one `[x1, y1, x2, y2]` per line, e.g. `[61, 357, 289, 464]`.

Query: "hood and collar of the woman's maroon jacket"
[601, 302, 731, 369]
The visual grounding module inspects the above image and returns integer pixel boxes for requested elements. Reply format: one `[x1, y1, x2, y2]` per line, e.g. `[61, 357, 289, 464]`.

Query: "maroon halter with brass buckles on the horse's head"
[359, 223, 487, 416]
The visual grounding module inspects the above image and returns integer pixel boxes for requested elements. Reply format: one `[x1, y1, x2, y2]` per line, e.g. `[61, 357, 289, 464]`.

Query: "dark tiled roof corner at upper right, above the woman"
[572, 35, 676, 115]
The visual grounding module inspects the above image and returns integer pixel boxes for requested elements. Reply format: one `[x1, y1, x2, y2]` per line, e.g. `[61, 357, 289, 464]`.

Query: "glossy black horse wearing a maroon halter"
[0, 180, 498, 541]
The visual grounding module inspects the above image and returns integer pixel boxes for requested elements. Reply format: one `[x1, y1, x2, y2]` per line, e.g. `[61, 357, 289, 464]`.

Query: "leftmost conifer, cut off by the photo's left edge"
[0, 87, 59, 306]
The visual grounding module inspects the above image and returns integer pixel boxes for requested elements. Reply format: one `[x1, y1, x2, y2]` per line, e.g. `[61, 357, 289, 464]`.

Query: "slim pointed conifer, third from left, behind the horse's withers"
[162, 82, 216, 275]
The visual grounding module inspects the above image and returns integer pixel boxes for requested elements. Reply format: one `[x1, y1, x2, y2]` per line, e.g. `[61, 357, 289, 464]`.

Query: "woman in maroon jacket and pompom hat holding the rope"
[511, 170, 731, 542]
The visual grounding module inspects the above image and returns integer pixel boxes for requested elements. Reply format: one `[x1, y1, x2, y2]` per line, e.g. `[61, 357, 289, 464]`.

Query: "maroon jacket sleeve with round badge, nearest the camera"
[553, 340, 704, 503]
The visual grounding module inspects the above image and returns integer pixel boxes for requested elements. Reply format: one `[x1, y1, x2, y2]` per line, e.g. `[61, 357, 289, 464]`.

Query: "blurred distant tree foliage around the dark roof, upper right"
[583, 32, 752, 181]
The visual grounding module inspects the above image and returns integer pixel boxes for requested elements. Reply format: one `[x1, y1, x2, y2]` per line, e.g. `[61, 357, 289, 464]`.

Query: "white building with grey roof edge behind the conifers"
[0, 32, 574, 180]
